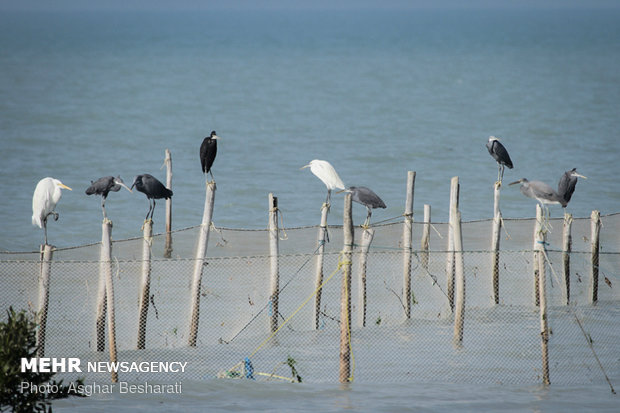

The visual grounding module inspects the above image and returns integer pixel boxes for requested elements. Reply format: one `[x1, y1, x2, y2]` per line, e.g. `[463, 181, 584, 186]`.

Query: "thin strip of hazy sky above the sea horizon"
[0, 0, 620, 10]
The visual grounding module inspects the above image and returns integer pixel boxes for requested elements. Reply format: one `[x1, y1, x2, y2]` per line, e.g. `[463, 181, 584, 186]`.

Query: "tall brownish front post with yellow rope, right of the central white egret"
[339, 193, 354, 383]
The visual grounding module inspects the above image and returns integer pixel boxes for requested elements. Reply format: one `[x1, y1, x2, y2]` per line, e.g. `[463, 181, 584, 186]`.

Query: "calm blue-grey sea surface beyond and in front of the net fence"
[0, 10, 620, 412]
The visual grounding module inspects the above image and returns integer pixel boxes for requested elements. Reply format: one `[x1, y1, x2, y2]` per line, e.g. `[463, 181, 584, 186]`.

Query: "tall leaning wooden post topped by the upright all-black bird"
[188, 182, 217, 347]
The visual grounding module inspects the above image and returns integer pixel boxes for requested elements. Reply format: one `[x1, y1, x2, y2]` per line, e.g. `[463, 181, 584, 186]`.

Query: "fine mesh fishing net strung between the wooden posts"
[0, 215, 620, 384]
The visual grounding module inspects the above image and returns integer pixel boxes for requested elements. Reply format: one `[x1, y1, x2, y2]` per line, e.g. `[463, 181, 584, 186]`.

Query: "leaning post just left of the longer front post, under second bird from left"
[95, 218, 112, 351]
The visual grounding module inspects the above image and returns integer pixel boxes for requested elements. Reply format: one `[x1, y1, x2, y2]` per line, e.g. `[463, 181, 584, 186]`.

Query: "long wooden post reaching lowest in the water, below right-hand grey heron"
[534, 205, 550, 385]
